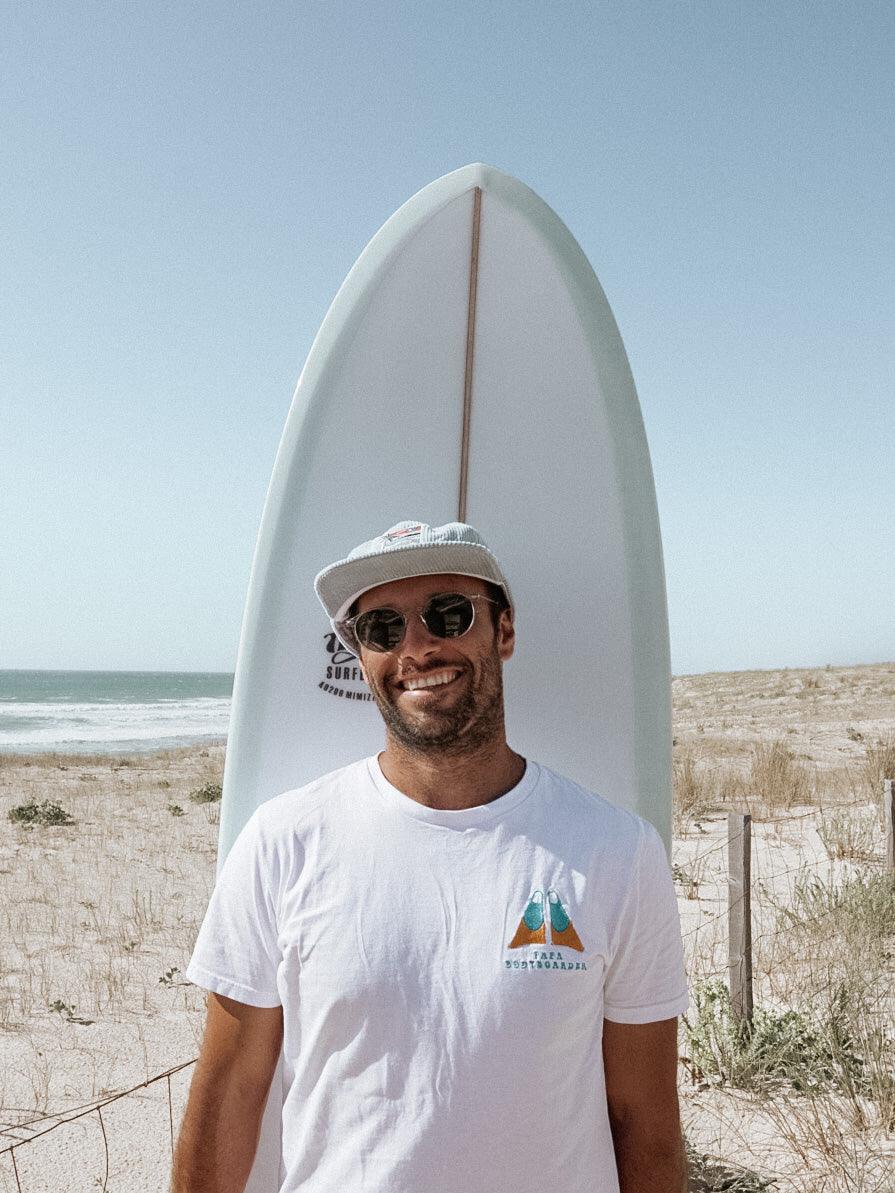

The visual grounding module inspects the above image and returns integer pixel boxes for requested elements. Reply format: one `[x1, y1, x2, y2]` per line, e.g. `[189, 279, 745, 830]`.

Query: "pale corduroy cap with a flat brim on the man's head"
[314, 521, 513, 630]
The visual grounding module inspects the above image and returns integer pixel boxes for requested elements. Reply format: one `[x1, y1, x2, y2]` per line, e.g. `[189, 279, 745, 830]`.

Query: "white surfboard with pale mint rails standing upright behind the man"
[218, 165, 671, 1193]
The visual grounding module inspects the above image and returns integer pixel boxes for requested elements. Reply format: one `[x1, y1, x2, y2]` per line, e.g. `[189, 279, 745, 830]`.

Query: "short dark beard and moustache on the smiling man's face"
[368, 644, 504, 756]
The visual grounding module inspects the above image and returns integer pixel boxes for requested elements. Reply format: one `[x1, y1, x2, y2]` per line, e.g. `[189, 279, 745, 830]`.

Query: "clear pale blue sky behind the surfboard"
[0, 0, 895, 673]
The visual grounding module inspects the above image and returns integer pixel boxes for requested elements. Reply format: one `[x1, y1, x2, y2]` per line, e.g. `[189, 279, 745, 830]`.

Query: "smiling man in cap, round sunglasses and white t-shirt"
[173, 523, 687, 1193]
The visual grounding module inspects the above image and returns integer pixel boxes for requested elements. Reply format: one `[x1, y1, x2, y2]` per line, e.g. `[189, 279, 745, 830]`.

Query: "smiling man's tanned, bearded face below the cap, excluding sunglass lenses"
[356, 574, 514, 754]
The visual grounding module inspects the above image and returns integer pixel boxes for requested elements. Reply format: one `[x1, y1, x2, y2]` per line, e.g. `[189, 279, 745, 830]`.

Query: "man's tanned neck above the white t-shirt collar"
[379, 735, 525, 811]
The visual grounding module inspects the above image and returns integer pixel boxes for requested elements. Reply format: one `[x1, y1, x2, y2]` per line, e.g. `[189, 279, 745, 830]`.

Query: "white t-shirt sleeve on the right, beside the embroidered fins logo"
[604, 821, 689, 1024]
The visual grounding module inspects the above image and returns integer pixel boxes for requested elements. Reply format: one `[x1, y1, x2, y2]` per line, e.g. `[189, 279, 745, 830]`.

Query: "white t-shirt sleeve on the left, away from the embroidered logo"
[186, 812, 280, 1007]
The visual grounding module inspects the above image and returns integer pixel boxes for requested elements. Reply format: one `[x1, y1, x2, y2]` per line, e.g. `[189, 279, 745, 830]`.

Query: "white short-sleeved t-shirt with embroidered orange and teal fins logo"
[186, 758, 687, 1193]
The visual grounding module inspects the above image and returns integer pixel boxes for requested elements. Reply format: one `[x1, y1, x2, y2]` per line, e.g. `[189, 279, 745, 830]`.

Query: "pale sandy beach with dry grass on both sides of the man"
[0, 663, 895, 1193]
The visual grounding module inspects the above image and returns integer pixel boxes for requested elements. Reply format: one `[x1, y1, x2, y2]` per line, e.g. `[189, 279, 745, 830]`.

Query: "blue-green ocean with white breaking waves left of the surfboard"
[0, 670, 233, 754]
